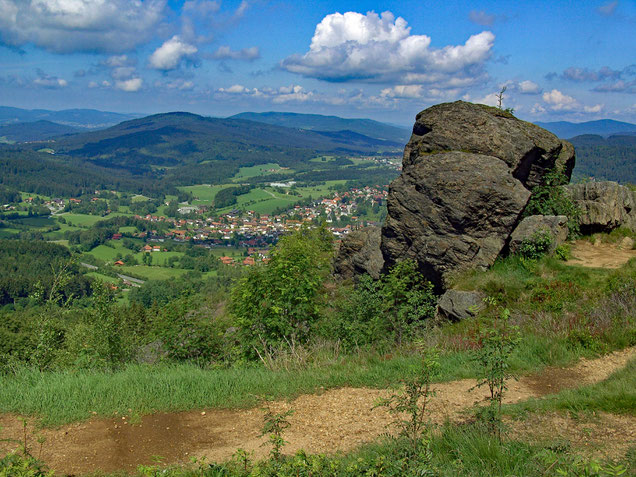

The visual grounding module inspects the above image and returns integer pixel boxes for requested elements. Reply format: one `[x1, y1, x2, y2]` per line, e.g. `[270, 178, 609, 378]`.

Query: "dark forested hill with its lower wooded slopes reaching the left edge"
[0, 113, 404, 196]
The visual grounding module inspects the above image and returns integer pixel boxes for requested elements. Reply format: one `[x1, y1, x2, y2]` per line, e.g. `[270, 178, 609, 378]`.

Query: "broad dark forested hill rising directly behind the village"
[52, 112, 403, 166]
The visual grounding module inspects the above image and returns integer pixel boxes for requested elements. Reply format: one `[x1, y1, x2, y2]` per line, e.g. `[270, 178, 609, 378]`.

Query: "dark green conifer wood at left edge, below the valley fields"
[0, 240, 90, 305]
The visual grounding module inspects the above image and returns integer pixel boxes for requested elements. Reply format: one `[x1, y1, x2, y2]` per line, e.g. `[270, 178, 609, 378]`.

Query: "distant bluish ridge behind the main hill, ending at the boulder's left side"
[232, 112, 411, 144]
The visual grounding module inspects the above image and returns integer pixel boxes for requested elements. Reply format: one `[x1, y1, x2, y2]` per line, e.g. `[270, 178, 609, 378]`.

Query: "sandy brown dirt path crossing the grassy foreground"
[0, 348, 636, 475]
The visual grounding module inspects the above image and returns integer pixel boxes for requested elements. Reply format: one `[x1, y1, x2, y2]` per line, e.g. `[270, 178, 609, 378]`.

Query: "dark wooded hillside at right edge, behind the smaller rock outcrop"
[569, 134, 636, 184]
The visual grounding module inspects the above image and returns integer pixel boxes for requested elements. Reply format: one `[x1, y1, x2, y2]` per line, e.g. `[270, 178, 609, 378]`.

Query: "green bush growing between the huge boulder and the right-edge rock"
[523, 169, 581, 237]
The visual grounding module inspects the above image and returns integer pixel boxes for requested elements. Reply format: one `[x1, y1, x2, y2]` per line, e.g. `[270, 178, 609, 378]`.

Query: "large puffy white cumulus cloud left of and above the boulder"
[280, 12, 495, 86]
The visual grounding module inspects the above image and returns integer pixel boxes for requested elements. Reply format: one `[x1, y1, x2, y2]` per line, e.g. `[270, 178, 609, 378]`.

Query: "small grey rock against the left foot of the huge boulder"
[334, 227, 384, 279]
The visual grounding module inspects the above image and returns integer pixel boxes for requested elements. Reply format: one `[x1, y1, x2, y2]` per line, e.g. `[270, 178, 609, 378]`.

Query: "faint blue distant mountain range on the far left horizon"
[0, 106, 143, 129]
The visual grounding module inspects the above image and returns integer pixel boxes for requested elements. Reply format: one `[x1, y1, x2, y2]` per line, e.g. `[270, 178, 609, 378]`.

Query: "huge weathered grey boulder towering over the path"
[381, 101, 574, 290]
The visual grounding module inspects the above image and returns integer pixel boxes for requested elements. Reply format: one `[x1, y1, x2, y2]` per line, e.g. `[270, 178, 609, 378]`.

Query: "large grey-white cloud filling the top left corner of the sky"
[0, 0, 166, 53]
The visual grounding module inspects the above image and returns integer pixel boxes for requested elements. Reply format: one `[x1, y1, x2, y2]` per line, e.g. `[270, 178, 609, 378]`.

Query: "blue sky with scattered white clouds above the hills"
[0, 0, 636, 126]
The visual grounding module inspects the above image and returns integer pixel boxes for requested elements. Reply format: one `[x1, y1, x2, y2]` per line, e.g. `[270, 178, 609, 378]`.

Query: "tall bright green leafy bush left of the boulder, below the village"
[231, 226, 332, 351]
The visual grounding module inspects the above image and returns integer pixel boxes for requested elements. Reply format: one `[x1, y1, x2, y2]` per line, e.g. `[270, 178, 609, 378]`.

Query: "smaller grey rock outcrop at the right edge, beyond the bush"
[566, 181, 636, 233]
